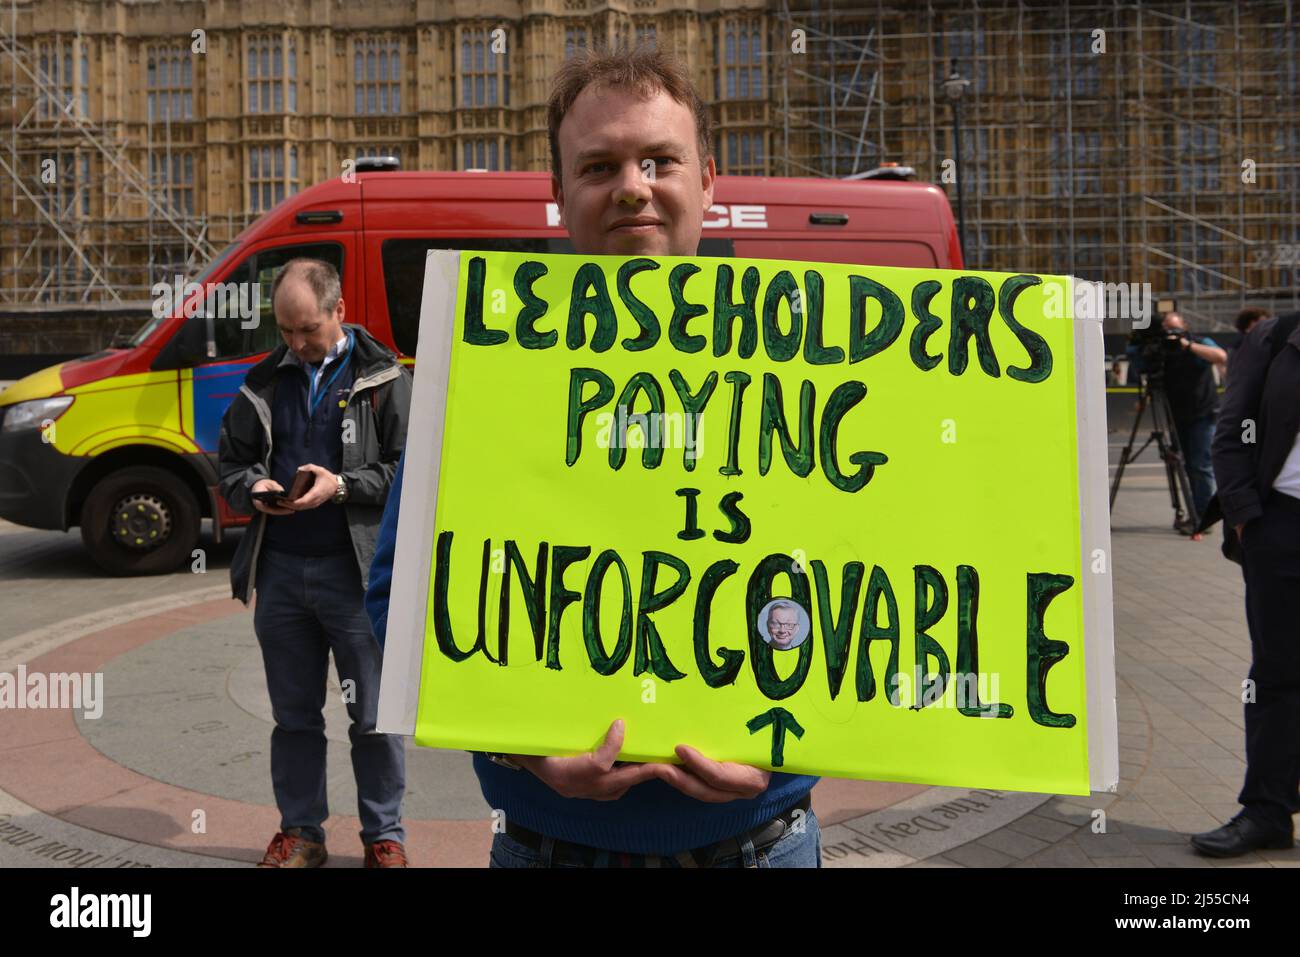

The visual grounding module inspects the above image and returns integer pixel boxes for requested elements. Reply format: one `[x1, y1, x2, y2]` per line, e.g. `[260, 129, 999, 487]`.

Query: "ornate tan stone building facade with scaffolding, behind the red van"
[0, 0, 1300, 329]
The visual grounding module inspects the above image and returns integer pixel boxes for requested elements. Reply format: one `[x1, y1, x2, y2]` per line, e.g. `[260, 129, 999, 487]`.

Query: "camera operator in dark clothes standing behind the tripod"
[1164, 312, 1227, 515]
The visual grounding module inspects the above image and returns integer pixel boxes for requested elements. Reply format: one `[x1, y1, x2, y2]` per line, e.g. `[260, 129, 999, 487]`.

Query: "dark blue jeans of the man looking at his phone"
[254, 549, 406, 844]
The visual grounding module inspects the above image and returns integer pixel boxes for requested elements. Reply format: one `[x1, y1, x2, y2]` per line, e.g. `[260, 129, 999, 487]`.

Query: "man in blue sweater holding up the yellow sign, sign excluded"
[367, 49, 820, 867]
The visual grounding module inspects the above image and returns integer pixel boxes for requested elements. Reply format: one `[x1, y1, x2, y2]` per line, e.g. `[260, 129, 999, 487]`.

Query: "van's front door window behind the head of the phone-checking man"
[208, 243, 345, 359]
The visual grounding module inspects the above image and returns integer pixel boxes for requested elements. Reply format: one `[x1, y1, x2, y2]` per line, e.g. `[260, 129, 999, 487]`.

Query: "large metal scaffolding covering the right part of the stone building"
[770, 0, 1300, 329]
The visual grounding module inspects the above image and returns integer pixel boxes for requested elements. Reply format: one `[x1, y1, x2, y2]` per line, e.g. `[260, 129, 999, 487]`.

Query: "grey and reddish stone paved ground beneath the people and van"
[0, 447, 1300, 867]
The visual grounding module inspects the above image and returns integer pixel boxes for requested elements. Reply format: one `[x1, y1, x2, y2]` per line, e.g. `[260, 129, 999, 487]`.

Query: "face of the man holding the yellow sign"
[551, 86, 714, 256]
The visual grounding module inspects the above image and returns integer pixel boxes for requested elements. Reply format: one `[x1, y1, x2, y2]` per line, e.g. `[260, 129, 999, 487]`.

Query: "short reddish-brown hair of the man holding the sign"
[546, 46, 712, 176]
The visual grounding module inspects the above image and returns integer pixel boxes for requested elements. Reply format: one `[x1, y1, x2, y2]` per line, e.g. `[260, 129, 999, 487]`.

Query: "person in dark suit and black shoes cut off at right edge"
[1192, 315, 1300, 857]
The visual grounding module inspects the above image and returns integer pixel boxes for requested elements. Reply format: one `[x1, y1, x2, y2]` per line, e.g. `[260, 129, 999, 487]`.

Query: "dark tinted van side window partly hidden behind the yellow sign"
[381, 237, 732, 356]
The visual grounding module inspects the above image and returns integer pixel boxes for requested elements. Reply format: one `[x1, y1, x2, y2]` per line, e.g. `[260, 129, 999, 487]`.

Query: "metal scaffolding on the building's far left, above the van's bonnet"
[0, 0, 215, 304]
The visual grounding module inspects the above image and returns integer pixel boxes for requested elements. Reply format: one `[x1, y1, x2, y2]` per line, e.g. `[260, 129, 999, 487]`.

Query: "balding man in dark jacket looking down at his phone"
[221, 259, 411, 867]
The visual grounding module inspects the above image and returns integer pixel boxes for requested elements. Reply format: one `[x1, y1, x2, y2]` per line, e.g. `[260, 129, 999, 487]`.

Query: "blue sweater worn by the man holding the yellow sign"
[365, 454, 818, 856]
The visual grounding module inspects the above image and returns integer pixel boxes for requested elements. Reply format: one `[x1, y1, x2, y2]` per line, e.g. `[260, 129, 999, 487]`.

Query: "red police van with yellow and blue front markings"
[0, 160, 962, 575]
